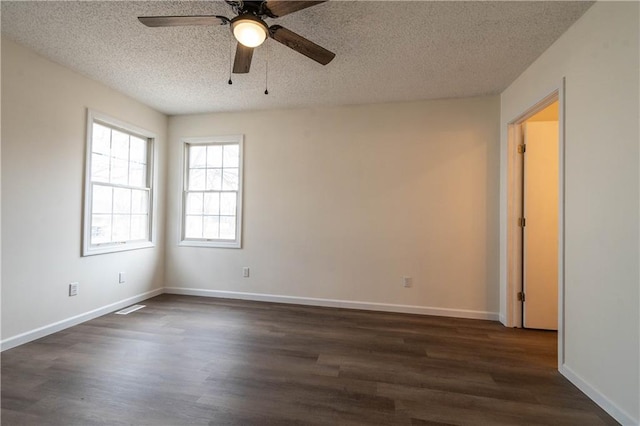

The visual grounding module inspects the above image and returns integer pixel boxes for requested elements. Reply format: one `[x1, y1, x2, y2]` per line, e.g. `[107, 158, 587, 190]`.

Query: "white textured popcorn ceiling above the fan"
[1, 0, 592, 114]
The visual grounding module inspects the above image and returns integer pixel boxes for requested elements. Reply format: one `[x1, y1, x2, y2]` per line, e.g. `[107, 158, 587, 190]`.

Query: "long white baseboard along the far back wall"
[164, 287, 498, 321]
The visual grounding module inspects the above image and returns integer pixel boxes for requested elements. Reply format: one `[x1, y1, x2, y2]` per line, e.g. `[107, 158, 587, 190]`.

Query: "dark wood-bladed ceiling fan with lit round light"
[138, 0, 336, 74]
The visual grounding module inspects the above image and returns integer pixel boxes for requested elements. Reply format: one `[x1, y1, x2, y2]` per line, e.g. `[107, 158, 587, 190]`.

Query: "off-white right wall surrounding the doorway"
[500, 2, 640, 424]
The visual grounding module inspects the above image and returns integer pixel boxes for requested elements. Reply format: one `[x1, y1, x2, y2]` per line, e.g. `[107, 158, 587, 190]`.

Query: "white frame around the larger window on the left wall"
[82, 109, 157, 256]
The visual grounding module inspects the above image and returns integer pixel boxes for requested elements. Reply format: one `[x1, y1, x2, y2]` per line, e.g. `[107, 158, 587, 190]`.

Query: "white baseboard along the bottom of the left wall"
[0, 288, 164, 352]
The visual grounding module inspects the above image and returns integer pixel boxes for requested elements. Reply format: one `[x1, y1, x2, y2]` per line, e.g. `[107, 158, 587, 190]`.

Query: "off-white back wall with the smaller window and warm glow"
[166, 98, 499, 318]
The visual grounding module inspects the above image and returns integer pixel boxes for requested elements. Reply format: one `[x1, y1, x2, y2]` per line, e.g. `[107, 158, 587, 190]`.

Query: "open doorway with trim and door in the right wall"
[505, 85, 564, 354]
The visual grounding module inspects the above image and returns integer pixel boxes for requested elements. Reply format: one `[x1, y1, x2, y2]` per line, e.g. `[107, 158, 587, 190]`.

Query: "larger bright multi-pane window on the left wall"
[82, 111, 155, 256]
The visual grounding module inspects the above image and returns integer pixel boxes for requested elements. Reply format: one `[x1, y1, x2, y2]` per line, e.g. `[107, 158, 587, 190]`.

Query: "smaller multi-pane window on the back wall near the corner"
[181, 136, 243, 248]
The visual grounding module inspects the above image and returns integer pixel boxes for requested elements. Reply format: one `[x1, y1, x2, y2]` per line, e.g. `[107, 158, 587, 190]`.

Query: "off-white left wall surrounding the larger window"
[2, 39, 167, 342]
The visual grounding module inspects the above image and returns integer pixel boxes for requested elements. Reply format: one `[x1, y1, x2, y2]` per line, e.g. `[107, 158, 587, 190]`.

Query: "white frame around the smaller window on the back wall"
[178, 135, 244, 249]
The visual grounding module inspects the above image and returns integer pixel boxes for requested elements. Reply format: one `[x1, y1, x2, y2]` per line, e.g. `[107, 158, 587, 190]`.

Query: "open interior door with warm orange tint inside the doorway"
[523, 121, 559, 330]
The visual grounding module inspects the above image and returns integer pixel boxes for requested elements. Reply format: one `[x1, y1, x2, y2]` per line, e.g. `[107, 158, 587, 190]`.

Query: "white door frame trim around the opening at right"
[503, 78, 565, 368]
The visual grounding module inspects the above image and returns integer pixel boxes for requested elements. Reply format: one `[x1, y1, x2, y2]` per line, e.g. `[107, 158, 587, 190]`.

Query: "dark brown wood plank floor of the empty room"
[2, 295, 617, 426]
